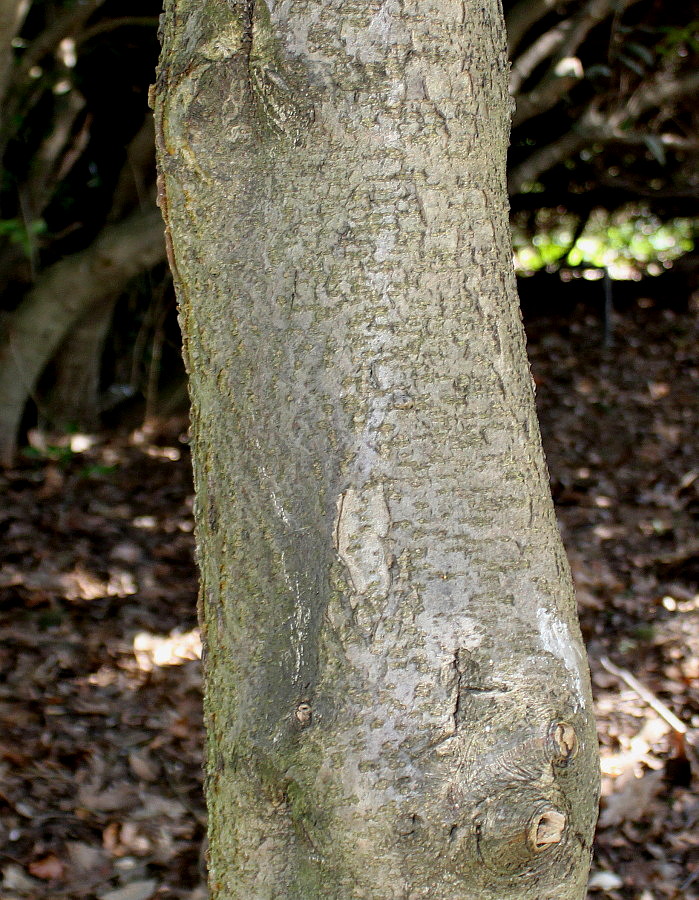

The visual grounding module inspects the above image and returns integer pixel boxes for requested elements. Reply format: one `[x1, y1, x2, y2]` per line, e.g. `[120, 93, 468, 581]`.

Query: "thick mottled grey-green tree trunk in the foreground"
[153, 0, 597, 900]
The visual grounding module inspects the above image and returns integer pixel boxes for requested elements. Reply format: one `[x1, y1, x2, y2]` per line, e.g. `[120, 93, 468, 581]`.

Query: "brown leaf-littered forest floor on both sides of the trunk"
[0, 302, 699, 900]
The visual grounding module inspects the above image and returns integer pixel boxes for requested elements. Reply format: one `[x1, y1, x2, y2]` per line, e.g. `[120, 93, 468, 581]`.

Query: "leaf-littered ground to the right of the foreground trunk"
[530, 306, 699, 900]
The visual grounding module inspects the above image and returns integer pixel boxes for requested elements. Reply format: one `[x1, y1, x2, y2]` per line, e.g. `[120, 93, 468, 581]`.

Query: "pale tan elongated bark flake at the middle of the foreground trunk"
[335, 484, 391, 600]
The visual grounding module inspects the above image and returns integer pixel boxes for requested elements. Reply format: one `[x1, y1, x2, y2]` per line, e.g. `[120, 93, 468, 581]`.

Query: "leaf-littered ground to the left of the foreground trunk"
[0, 421, 206, 900]
